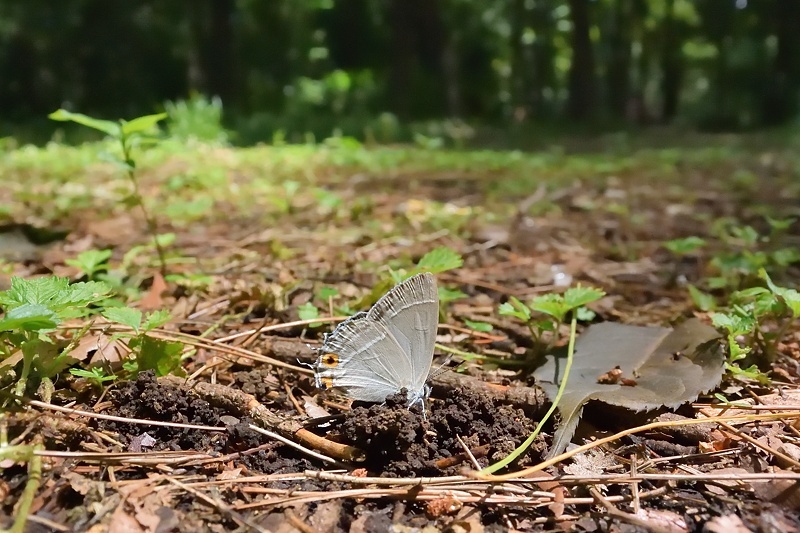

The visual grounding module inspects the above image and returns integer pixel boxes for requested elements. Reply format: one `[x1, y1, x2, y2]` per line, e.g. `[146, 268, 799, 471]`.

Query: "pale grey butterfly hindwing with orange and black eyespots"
[314, 313, 412, 402]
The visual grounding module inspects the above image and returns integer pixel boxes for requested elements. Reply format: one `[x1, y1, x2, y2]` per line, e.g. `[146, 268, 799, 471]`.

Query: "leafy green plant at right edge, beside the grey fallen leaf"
[711, 268, 800, 383]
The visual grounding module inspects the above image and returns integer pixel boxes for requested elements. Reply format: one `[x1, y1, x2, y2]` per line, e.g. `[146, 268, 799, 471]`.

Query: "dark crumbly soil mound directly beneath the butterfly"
[336, 388, 544, 477]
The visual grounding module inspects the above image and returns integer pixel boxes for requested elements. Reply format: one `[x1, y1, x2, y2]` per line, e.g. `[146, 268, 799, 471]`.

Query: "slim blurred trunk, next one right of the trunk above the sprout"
[606, 0, 634, 120]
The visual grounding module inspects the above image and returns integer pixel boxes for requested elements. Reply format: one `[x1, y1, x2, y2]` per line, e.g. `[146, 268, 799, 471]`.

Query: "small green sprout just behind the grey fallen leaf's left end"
[499, 287, 605, 359]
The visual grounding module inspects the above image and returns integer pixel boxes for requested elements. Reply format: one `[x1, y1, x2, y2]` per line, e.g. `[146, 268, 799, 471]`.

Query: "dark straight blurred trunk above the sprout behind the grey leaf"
[567, 0, 595, 121]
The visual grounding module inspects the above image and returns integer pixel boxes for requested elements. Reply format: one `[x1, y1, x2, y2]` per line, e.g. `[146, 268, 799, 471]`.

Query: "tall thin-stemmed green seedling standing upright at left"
[48, 109, 167, 275]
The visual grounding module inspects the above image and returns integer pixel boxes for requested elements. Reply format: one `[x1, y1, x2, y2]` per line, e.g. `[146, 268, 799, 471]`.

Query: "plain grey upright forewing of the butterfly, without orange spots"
[367, 272, 439, 398]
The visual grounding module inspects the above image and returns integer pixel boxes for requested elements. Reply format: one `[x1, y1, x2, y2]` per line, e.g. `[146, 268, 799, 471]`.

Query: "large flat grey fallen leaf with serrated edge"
[534, 318, 725, 459]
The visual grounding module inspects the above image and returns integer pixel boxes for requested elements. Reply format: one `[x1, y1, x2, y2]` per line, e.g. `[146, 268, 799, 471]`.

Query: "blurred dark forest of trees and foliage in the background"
[0, 0, 800, 143]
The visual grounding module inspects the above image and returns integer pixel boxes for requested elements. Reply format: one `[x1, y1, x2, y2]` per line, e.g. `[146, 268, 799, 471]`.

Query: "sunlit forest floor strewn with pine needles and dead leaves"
[0, 131, 800, 533]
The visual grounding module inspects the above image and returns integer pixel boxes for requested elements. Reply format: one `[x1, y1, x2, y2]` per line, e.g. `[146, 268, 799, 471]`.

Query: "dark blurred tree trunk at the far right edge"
[762, 1, 800, 126]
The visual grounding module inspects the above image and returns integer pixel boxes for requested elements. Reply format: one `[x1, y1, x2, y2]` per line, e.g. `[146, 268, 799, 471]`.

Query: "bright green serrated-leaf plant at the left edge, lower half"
[0, 277, 110, 396]
